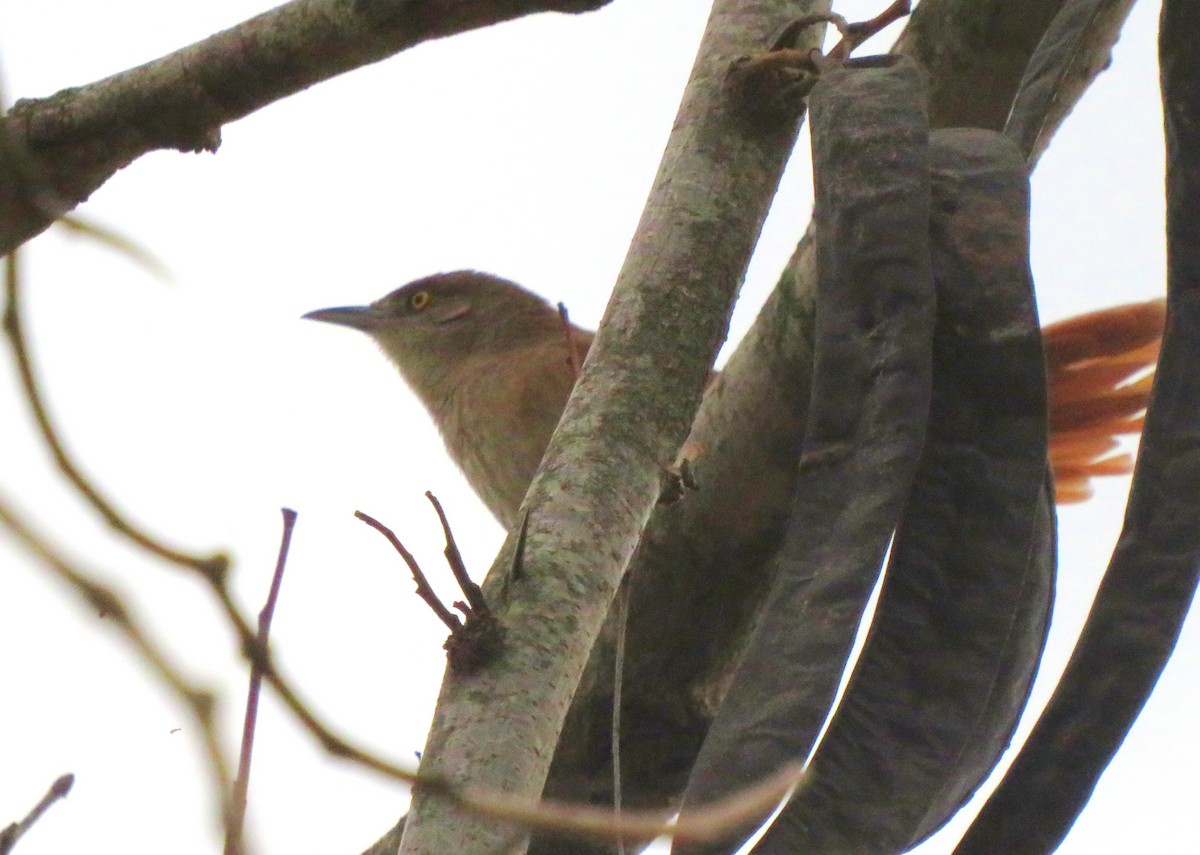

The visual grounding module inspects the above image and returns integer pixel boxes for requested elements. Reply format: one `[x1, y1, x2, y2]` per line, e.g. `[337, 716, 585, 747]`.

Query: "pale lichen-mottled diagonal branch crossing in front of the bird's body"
[401, 0, 828, 855]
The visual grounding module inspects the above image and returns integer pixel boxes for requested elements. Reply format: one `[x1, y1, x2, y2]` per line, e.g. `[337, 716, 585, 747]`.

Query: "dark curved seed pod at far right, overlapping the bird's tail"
[955, 0, 1200, 855]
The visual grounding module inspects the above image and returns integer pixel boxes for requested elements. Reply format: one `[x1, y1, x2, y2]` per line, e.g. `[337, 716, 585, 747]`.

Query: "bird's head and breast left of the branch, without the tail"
[304, 270, 593, 530]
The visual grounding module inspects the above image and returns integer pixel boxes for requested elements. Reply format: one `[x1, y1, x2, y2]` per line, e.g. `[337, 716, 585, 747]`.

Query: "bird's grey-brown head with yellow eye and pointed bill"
[304, 270, 562, 399]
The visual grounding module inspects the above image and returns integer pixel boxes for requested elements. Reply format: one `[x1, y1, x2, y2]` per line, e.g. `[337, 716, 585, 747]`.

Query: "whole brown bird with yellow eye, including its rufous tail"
[305, 270, 1165, 528]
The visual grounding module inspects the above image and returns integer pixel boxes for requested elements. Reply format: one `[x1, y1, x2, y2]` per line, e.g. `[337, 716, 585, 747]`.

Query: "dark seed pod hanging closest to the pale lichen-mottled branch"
[674, 53, 934, 853]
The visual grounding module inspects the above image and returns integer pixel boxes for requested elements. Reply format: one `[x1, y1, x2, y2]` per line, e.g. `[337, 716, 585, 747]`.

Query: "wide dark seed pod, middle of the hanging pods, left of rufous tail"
[755, 130, 1055, 855]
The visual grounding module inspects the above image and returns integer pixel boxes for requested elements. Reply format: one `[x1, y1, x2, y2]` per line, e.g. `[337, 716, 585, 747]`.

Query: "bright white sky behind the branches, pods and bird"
[0, 0, 1200, 855]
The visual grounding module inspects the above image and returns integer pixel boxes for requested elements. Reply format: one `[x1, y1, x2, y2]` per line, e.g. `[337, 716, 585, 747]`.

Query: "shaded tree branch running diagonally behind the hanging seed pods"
[533, 0, 1142, 855]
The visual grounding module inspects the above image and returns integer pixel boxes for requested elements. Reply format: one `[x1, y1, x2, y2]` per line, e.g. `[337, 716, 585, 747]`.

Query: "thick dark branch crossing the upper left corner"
[0, 0, 610, 255]
